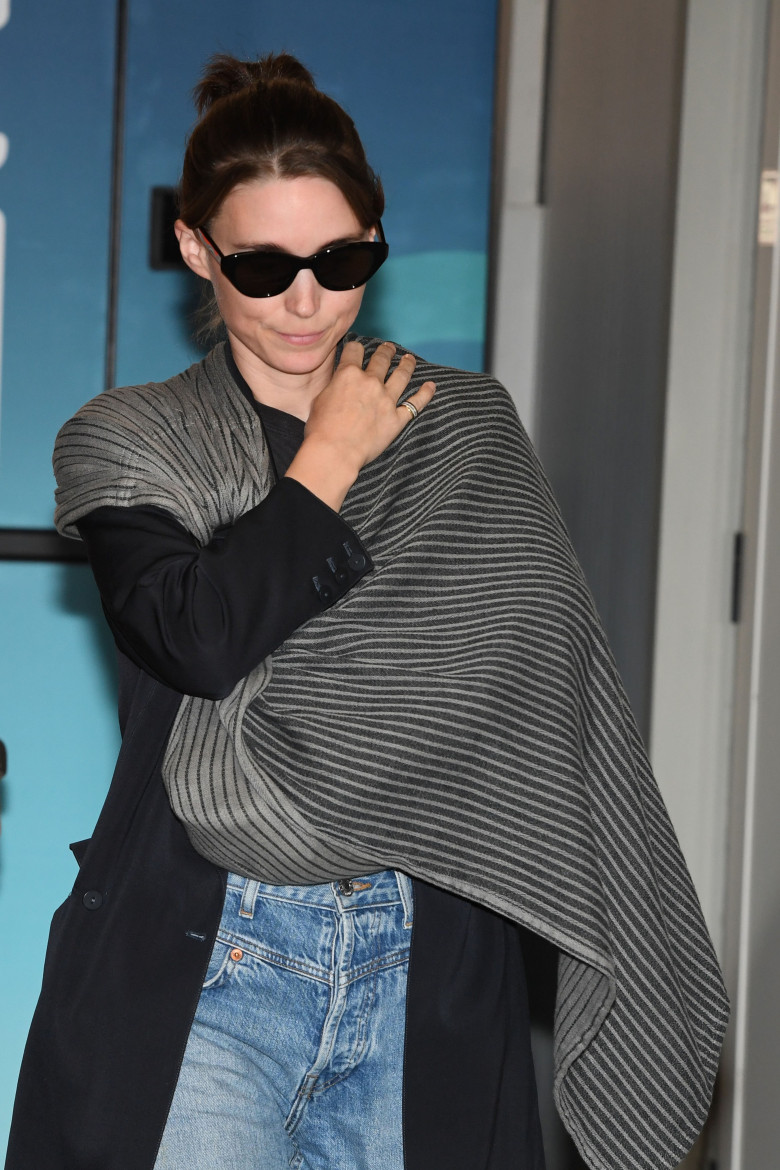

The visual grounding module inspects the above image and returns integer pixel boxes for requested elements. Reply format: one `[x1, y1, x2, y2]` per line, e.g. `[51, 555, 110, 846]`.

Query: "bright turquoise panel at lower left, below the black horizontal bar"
[0, 562, 119, 1141]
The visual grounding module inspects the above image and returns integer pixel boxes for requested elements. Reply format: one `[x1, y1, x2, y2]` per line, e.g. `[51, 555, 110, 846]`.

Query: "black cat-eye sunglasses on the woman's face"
[198, 223, 389, 296]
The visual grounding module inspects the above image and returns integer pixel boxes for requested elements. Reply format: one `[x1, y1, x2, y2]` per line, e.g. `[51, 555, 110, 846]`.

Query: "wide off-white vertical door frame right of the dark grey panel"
[650, 0, 766, 947]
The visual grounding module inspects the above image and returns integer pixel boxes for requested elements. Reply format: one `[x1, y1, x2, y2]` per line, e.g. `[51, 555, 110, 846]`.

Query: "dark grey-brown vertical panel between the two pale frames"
[537, 0, 685, 735]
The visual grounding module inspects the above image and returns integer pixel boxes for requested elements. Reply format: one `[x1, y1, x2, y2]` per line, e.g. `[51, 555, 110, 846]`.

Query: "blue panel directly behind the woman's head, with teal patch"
[117, 0, 495, 383]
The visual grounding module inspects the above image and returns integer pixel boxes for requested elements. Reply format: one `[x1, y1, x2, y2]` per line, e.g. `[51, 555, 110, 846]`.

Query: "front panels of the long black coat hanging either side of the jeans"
[6, 656, 544, 1170]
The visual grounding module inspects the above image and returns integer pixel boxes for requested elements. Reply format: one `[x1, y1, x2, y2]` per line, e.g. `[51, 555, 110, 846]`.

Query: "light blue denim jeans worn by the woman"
[154, 870, 413, 1170]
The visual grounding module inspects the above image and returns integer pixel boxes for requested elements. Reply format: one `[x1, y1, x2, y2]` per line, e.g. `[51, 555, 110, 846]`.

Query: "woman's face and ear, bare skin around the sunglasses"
[179, 177, 372, 388]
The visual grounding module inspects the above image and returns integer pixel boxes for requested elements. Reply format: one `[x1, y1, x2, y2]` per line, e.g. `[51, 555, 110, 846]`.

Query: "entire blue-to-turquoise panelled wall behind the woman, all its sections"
[0, 0, 495, 1148]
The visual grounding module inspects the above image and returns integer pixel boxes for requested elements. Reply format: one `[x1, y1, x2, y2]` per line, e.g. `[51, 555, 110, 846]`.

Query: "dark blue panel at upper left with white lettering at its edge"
[0, 0, 115, 526]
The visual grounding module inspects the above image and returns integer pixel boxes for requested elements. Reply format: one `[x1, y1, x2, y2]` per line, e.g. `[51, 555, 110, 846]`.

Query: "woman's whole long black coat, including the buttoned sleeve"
[6, 362, 543, 1170]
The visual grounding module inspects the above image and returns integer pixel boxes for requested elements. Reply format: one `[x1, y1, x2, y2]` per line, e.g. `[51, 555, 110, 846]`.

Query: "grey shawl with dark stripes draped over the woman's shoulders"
[55, 347, 727, 1170]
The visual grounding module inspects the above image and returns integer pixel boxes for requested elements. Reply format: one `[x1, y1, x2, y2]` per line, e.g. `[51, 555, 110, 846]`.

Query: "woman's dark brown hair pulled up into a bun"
[179, 53, 385, 228]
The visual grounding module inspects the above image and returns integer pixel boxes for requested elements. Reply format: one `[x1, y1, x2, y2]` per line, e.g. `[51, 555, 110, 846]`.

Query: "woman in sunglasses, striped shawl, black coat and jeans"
[7, 55, 726, 1170]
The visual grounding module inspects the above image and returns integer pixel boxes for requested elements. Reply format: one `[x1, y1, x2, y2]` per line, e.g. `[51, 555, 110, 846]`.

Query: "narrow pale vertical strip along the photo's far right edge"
[718, 0, 780, 1170]
